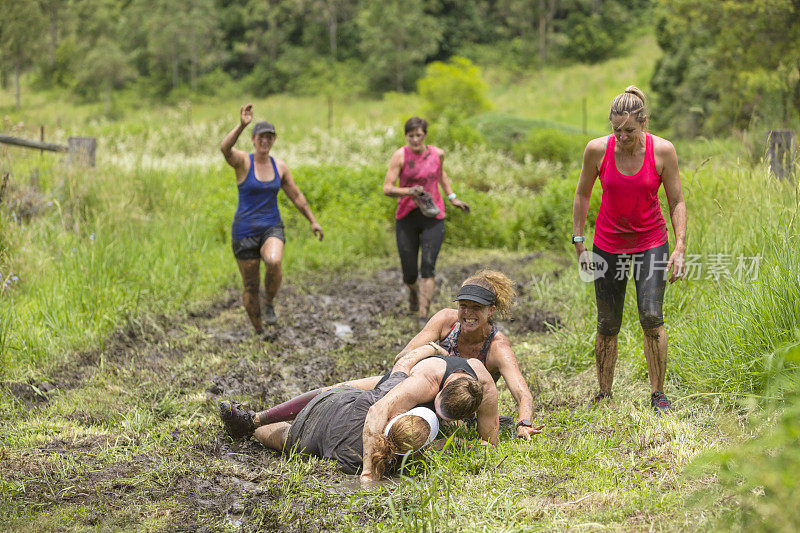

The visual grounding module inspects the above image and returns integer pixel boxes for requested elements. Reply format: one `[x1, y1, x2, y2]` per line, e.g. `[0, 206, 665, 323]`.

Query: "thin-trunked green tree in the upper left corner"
[0, 0, 44, 109]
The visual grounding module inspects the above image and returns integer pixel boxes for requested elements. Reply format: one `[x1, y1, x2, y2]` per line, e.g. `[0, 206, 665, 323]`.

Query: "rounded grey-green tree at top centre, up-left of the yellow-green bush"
[358, 0, 442, 91]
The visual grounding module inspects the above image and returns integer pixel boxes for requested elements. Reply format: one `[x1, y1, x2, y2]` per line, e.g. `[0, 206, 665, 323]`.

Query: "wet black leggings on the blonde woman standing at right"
[593, 243, 669, 336]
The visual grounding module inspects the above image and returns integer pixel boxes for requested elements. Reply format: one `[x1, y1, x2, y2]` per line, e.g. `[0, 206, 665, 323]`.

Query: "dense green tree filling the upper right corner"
[651, 0, 800, 135]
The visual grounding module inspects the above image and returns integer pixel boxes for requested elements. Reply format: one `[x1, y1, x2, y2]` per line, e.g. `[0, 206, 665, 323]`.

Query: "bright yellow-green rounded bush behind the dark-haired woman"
[417, 57, 491, 123]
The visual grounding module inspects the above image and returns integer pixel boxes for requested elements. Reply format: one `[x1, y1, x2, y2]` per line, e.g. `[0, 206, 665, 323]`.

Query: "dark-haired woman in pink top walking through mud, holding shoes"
[383, 117, 469, 324]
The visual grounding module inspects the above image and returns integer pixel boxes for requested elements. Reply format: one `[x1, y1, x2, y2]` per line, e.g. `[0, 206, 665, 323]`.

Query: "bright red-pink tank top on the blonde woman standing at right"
[594, 133, 667, 250]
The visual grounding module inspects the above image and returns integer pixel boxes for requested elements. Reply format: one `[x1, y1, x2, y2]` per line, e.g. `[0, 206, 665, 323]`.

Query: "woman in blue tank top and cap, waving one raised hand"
[220, 104, 323, 333]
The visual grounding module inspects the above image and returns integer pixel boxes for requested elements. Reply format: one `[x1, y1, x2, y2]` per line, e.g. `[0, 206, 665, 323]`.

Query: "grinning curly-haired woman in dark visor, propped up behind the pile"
[396, 270, 544, 440]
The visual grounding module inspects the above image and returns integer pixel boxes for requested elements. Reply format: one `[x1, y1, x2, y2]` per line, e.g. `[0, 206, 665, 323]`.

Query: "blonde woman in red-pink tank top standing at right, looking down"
[572, 85, 686, 413]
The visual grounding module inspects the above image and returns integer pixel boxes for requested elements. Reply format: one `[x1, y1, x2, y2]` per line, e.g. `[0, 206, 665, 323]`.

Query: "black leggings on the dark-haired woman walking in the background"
[395, 209, 444, 284]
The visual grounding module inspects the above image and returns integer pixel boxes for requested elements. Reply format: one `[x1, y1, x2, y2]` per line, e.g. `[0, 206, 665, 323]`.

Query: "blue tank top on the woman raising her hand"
[231, 154, 282, 240]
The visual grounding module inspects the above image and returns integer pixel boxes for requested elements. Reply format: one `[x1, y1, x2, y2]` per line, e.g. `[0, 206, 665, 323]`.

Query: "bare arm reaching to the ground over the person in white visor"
[361, 368, 441, 482]
